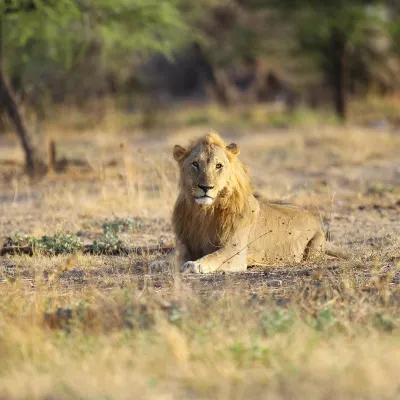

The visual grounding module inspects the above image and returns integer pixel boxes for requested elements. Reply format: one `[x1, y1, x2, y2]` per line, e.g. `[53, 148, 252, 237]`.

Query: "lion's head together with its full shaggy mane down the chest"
[172, 132, 252, 253]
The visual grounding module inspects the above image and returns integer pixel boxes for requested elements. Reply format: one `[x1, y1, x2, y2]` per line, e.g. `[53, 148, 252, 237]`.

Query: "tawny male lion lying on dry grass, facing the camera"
[150, 132, 347, 273]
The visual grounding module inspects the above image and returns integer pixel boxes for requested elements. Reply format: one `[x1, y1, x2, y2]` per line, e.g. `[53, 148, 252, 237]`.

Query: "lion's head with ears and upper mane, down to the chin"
[173, 132, 248, 207]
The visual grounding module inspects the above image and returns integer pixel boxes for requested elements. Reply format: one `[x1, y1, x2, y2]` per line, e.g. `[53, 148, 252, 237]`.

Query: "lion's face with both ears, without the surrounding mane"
[174, 143, 239, 206]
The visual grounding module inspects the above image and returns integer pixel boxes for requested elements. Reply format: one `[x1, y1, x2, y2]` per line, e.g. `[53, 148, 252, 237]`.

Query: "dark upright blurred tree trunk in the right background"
[331, 30, 348, 121]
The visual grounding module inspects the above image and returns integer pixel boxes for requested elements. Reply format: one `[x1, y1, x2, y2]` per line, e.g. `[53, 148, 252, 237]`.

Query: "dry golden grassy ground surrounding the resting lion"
[0, 108, 400, 400]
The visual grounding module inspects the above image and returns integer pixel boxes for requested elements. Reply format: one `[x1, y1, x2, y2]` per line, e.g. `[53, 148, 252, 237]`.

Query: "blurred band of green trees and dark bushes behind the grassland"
[0, 0, 400, 175]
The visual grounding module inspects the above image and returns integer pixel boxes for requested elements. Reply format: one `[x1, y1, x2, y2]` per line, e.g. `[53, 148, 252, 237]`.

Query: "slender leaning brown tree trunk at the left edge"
[0, 17, 47, 177]
